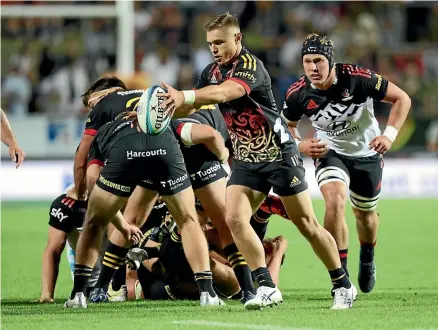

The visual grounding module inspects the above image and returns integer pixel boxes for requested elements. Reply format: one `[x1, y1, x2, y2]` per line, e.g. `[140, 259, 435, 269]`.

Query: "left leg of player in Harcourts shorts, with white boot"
[65, 186, 126, 308]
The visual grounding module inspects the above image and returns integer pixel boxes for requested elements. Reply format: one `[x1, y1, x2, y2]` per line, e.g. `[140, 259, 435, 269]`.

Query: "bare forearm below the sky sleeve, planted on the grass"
[39, 227, 67, 303]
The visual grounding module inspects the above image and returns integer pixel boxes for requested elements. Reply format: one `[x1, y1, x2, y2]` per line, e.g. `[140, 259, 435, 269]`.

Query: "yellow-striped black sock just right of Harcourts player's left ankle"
[95, 241, 129, 291]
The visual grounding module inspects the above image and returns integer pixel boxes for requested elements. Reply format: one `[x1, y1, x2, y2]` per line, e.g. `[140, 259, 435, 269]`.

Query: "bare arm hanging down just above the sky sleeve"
[73, 134, 94, 200]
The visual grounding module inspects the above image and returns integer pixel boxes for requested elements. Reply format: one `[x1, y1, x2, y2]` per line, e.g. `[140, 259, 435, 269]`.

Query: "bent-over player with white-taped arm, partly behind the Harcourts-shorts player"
[172, 105, 255, 303]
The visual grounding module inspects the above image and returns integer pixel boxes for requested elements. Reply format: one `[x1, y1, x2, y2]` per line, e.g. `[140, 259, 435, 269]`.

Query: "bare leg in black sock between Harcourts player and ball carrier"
[195, 171, 256, 300]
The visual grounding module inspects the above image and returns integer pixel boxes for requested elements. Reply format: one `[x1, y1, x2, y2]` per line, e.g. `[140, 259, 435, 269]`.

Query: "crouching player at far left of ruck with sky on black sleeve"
[39, 185, 100, 303]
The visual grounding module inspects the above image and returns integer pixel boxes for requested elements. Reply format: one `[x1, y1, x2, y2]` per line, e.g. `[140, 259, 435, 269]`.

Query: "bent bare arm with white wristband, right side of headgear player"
[369, 82, 411, 154]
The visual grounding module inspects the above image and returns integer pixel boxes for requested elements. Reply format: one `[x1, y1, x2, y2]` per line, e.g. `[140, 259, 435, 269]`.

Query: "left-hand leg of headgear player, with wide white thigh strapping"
[315, 151, 350, 276]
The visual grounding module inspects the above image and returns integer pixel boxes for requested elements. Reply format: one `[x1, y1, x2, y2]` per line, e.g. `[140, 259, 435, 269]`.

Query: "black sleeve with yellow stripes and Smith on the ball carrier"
[229, 53, 265, 94]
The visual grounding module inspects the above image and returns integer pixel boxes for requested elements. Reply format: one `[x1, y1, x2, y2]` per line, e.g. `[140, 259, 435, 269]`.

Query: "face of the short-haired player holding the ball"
[207, 28, 242, 65]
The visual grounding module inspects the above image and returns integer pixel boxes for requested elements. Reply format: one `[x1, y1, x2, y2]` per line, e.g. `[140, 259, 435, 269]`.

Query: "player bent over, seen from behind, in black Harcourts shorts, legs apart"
[65, 114, 223, 308]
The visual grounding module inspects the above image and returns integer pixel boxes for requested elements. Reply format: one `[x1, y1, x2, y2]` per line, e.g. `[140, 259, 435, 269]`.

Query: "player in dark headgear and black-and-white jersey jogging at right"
[283, 34, 411, 293]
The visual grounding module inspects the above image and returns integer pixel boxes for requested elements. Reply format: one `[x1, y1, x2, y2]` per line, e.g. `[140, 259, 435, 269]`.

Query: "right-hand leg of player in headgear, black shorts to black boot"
[350, 155, 383, 293]
